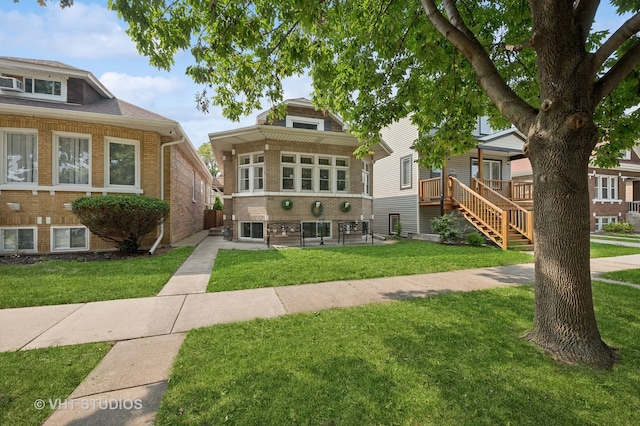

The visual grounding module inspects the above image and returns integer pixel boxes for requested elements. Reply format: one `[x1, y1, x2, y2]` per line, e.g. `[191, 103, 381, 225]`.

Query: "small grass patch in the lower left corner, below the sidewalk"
[0, 343, 111, 426]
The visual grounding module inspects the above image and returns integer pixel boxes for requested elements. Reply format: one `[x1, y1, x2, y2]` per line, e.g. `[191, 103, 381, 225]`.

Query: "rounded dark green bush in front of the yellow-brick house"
[72, 195, 169, 253]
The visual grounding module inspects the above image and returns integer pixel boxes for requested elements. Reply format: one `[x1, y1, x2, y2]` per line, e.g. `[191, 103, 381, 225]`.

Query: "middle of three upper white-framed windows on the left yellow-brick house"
[54, 133, 91, 185]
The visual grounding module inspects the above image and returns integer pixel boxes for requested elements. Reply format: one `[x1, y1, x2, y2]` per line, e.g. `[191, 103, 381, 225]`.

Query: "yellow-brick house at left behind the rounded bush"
[0, 57, 212, 254]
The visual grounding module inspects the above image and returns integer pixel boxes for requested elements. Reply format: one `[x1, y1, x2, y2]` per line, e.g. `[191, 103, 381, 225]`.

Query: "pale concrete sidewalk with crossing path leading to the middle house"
[0, 233, 640, 426]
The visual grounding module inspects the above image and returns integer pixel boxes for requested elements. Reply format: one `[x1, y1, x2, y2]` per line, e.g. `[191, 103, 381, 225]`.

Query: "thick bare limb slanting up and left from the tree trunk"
[421, 0, 537, 134]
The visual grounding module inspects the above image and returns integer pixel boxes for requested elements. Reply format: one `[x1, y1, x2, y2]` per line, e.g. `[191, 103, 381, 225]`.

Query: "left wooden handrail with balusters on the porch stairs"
[449, 176, 509, 250]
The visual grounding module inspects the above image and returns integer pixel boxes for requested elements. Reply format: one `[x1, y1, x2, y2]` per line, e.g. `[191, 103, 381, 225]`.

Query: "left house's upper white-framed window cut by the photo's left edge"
[0, 130, 38, 183]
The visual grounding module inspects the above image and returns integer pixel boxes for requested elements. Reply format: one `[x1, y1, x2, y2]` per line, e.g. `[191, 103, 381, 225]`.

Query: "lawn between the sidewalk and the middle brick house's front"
[207, 240, 532, 292]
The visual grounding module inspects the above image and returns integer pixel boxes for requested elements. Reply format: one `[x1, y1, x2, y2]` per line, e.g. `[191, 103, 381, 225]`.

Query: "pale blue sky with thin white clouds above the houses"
[0, 0, 622, 148]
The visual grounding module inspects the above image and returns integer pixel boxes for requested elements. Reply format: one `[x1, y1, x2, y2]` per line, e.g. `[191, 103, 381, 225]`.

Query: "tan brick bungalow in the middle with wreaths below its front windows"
[209, 99, 391, 243]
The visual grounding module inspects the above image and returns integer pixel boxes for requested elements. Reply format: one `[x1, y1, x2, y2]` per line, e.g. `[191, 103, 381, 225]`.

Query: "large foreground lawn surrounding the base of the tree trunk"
[157, 283, 640, 425]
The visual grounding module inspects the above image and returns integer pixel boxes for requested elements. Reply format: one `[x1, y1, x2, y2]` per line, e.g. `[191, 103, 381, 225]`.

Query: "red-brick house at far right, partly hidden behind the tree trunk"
[513, 146, 640, 232]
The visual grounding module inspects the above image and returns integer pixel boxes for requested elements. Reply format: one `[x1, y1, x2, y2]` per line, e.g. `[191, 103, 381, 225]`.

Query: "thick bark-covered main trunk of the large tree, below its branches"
[527, 108, 615, 369]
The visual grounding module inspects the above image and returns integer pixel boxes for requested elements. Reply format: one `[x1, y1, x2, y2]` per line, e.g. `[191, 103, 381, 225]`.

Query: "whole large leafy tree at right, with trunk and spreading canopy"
[47, 0, 640, 368]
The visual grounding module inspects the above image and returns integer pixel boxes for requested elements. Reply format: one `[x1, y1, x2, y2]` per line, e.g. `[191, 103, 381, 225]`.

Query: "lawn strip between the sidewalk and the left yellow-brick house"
[0, 247, 193, 308]
